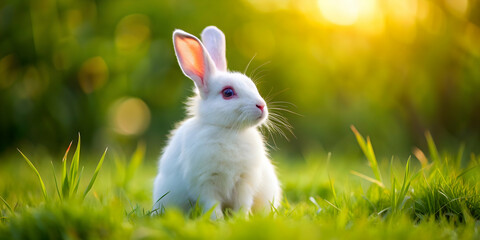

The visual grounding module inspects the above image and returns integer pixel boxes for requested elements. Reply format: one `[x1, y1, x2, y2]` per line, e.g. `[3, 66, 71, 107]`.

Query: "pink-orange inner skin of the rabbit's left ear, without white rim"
[175, 36, 205, 85]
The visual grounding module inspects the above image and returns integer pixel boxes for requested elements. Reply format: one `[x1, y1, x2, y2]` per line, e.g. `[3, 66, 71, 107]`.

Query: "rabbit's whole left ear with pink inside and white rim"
[173, 30, 215, 94]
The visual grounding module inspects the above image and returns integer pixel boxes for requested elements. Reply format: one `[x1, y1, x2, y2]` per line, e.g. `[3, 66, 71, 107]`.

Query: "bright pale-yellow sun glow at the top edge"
[318, 0, 360, 26]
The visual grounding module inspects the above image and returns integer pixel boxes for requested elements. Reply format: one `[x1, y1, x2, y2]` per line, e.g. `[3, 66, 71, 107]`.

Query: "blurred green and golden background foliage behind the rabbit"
[0, 0, 480, 161]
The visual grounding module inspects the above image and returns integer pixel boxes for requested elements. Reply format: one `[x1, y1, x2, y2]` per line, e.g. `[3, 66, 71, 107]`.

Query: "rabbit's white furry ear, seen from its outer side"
[202, 26, 227, 71]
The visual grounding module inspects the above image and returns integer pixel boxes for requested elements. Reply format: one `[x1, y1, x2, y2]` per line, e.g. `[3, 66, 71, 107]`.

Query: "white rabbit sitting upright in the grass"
[153, 26, 282, 219]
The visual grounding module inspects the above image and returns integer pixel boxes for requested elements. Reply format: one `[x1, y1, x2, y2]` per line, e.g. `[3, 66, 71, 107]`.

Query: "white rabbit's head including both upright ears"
[173, 26, 268, 129]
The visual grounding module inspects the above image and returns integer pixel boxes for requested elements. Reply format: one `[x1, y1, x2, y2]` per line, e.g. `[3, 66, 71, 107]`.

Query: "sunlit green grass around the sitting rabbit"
[0, 127, 480, 240]
